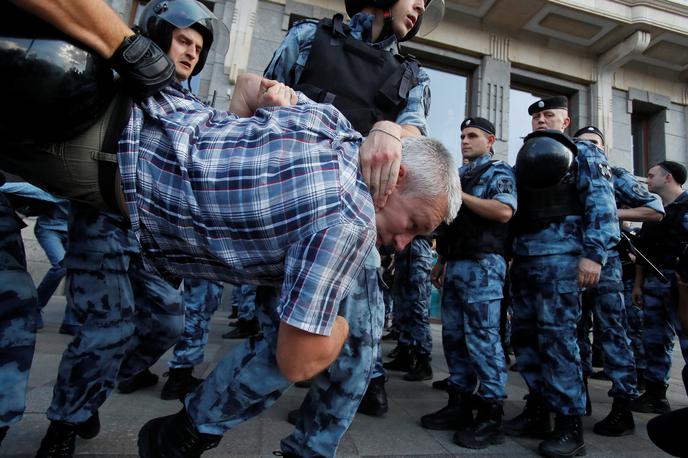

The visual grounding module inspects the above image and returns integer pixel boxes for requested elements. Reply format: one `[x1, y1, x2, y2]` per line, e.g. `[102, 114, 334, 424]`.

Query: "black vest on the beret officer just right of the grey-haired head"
[437, 161, 509, 261]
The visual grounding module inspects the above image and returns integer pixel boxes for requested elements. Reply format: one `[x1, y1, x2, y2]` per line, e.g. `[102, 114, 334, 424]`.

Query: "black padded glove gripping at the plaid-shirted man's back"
[110, 33, 175, 98]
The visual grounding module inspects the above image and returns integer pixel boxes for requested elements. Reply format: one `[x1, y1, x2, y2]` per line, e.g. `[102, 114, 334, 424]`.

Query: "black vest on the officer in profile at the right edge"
[638, 195, 688, 268]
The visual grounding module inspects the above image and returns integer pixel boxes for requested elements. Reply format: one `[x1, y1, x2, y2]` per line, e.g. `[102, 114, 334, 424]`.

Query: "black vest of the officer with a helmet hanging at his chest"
[514, 162, 584, 234]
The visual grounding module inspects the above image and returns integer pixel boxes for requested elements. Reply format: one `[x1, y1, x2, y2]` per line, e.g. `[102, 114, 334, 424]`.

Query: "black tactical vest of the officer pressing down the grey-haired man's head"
[294, 14, 420, 135]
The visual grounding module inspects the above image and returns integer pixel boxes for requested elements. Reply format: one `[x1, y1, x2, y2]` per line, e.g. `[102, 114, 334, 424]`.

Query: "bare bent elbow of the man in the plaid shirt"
[277, 316, 349, 382]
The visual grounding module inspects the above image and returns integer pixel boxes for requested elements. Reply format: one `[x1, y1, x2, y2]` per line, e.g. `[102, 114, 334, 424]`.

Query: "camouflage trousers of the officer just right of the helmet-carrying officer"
[578, 256, 639, 399]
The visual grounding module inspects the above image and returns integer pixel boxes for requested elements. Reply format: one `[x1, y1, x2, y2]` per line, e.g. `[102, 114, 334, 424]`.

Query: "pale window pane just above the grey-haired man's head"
[423, 66, 468, 164]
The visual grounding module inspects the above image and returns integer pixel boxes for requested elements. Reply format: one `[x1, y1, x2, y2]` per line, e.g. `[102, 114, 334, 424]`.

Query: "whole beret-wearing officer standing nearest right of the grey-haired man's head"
[421, 117, 517, 448]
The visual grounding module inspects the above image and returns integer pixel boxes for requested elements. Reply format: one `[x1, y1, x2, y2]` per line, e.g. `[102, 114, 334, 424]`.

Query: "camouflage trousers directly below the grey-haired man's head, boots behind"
[392, 238, 435, 355]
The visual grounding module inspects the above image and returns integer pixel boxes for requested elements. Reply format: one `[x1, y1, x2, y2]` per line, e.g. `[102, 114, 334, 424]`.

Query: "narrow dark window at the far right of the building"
[631, 100, 666, 177]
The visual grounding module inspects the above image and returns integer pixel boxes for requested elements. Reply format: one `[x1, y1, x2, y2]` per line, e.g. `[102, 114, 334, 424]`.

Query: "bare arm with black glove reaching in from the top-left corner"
[11, 0, 175, 97]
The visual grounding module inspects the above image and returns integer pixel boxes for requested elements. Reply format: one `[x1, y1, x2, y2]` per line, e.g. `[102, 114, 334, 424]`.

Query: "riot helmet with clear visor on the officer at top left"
[139, 0, 221, 76]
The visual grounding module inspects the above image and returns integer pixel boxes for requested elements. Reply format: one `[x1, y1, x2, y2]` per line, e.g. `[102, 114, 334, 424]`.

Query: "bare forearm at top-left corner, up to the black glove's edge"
[11, 0, 134, 59]
